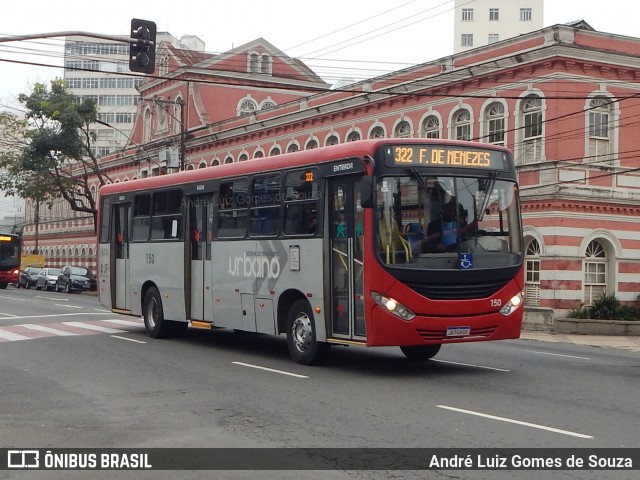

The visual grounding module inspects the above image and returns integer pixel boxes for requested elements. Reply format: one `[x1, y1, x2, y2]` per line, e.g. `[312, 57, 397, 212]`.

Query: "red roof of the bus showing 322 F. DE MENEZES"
[100, 138, 509, 195]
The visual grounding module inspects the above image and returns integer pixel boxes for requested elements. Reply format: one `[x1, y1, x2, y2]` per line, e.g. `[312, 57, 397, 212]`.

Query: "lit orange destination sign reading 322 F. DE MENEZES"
[385, 145, 505, 170]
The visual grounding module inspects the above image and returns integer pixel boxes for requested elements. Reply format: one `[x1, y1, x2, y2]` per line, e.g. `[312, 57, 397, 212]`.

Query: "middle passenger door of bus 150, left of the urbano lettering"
[188, 195, 213, 321]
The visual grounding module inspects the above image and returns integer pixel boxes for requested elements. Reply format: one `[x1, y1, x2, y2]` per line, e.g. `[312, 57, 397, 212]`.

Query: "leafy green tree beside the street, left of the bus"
[0, 79, 109, 230]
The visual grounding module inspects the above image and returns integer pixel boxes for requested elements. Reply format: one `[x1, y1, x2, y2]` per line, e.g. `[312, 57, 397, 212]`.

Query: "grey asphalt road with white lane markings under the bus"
[0, 288, 640, 479]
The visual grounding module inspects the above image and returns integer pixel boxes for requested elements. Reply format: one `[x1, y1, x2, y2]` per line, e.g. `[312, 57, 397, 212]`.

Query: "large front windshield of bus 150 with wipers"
[375, 173, 522, 269]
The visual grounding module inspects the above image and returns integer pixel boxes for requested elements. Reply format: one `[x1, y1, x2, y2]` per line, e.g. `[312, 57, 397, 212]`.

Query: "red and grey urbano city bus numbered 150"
[98, 139, 524, 364]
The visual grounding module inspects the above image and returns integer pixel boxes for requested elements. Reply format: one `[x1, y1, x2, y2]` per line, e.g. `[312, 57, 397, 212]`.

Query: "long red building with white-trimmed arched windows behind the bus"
[26, 22, 640, 318]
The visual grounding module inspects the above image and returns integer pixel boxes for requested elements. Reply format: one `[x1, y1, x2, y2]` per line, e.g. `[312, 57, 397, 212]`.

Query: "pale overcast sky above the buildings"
[0, 0, 638, 109]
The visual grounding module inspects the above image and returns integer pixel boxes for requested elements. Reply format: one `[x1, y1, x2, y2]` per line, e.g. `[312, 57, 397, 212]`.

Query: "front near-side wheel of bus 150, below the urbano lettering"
[287, 299, 331, 365]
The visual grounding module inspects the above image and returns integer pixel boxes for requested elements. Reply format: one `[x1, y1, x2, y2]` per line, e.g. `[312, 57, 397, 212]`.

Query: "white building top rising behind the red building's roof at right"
[453, 0, 544, 53]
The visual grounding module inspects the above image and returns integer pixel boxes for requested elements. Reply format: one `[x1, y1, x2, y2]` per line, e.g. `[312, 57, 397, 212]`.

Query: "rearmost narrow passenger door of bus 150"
[111, 203, 131, 310]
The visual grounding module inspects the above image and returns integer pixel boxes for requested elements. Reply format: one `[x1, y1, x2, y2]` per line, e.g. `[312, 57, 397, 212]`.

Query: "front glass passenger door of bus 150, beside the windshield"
[325, 177, 366, 341]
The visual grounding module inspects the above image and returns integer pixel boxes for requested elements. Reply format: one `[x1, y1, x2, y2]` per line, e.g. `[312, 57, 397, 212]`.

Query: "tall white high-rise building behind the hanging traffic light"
[64, 32, 204, 156]
